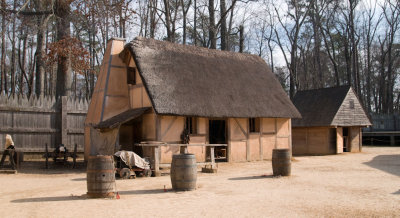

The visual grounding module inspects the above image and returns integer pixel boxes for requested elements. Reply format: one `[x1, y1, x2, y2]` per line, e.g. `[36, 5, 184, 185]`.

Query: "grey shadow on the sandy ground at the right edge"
[364, 154, 400, 176]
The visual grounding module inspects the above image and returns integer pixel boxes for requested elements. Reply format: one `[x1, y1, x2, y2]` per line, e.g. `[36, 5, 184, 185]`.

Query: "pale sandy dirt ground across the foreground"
[0, 147, 400, 217]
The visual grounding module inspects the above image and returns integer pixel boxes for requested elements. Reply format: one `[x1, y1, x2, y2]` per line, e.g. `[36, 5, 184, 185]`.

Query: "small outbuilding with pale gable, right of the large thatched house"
[292, 86, 371, 155]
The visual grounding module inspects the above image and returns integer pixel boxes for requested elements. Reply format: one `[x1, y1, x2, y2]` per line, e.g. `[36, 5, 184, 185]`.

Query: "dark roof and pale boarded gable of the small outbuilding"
[292, 86, 371, 127]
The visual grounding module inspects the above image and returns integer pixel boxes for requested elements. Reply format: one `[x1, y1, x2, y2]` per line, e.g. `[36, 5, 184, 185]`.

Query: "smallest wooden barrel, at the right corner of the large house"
[272, 149, 291, 176]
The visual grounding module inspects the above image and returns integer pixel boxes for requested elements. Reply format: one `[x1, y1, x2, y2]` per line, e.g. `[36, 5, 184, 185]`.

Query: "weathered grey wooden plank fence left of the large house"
[0, 95, 89, 152]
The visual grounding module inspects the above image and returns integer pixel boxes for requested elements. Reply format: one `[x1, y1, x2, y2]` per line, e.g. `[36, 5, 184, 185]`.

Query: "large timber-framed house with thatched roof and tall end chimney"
[85, 38, 300, 164]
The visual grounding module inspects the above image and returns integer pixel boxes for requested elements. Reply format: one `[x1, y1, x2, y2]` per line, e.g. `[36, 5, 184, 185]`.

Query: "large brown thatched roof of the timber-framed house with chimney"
[121, 38, 300, 118]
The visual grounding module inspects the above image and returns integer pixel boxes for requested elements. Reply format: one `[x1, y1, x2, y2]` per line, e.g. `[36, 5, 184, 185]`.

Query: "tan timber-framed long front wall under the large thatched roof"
[134, 115, 292, 164]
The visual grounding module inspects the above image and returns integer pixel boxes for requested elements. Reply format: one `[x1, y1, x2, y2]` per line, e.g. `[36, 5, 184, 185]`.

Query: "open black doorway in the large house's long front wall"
[208, 120, 228, 161]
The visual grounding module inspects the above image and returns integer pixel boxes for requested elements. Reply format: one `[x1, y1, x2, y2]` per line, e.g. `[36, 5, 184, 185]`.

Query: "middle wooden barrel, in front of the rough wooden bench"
[171, 154, 197, 191]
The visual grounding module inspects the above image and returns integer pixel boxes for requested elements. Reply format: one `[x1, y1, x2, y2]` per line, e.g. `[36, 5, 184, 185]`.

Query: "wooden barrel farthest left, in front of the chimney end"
[87, 155, 115, 198]
